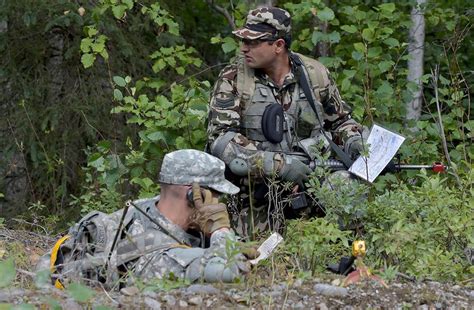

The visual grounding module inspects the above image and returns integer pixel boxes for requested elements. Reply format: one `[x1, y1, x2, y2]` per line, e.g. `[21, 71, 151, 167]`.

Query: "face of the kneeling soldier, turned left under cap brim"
[240, 39, 276, 69]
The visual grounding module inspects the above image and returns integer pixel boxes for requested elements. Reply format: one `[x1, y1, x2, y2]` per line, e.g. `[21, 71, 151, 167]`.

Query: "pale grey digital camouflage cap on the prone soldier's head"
[159, 150, 239, 194]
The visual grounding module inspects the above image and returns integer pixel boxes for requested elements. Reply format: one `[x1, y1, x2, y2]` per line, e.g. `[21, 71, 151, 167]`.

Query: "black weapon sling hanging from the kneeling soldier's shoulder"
[291, 53, 353, 168]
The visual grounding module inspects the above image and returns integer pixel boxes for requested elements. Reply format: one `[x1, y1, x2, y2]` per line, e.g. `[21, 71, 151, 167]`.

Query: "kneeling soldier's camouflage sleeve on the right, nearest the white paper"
[320, 69, 362, 145]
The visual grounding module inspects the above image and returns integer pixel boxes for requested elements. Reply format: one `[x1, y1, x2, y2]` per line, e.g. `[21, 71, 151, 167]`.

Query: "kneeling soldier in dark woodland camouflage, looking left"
[207, 7, 363, 239]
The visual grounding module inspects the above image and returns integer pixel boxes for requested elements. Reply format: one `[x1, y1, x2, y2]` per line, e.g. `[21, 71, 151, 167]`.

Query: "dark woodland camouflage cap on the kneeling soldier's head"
[232, 7, 291, 40]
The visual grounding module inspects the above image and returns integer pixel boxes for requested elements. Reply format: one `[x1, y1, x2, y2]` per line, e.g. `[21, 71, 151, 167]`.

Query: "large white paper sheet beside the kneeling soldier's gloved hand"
[349, 125, 405, 183]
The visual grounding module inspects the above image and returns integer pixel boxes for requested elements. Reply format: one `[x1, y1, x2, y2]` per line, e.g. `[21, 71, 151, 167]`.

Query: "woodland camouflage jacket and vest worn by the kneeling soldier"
[207, 55, 361, 173]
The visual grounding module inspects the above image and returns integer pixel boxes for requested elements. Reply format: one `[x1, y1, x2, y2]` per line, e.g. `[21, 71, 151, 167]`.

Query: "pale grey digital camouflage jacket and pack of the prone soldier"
[37, 196, 249, 289]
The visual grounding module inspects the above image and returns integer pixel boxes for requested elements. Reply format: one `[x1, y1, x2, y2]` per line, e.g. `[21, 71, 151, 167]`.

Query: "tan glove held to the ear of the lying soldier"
[190, 183, 230, 236]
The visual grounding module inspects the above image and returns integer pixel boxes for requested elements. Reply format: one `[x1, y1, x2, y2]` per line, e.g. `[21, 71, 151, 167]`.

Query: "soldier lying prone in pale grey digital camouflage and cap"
[39, 150, 258, 288]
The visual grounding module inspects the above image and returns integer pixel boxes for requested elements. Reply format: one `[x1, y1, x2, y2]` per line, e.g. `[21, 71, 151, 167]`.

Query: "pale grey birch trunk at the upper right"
[405, 0, 426, 131]
